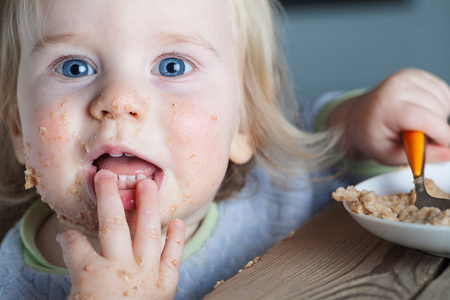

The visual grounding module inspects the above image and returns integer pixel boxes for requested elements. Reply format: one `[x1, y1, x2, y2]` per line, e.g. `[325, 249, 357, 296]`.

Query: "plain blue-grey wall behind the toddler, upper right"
[281, 0, 450, 101]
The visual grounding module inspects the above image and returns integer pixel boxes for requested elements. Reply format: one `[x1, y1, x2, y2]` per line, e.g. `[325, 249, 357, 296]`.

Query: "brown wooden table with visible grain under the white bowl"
[205, 203, 450, 300]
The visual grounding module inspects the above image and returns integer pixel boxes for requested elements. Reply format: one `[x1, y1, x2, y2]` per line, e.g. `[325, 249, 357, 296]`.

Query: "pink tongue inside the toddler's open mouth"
[96, 154, 156, 177]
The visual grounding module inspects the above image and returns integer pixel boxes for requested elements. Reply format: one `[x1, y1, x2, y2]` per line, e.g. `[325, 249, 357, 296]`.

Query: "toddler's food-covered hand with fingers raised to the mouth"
[57, 171, 184, 299]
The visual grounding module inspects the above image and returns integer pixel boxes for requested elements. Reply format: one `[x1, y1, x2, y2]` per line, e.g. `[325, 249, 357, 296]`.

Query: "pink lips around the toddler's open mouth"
[85, 145, 164, 204]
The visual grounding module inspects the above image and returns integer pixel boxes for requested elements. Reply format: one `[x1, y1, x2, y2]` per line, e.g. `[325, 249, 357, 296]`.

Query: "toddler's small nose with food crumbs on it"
[90, 84, 148, 120]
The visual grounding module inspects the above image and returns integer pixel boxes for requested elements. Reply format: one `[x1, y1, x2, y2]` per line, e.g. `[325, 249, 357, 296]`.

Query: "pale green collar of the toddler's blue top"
[20, 201, 219, 274]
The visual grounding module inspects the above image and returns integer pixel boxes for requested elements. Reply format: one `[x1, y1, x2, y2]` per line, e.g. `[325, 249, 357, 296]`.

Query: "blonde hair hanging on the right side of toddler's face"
[217, 0, 338, 199]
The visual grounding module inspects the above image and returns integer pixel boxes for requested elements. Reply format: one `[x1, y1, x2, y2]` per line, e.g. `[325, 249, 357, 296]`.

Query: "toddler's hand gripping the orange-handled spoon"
[328, 69, 450, 165]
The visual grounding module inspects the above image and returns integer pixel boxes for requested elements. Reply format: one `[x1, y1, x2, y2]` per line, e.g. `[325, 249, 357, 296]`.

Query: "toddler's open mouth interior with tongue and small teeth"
[93, 152, 162, 210]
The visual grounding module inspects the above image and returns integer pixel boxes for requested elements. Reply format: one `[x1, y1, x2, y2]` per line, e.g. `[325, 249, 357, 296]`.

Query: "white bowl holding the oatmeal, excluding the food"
[344, 163, 450, 258]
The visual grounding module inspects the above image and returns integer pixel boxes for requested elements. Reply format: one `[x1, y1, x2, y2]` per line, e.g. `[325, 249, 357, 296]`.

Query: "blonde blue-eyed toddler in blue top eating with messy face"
[0, 0, 450, 299]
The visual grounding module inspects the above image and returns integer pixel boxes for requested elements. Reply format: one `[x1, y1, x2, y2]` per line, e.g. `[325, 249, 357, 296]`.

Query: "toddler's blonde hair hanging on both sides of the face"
[0, 0, 333, 203]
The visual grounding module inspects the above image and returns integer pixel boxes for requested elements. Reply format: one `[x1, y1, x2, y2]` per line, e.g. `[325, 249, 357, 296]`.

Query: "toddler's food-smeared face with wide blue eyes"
[14, 0, 251, 230]
